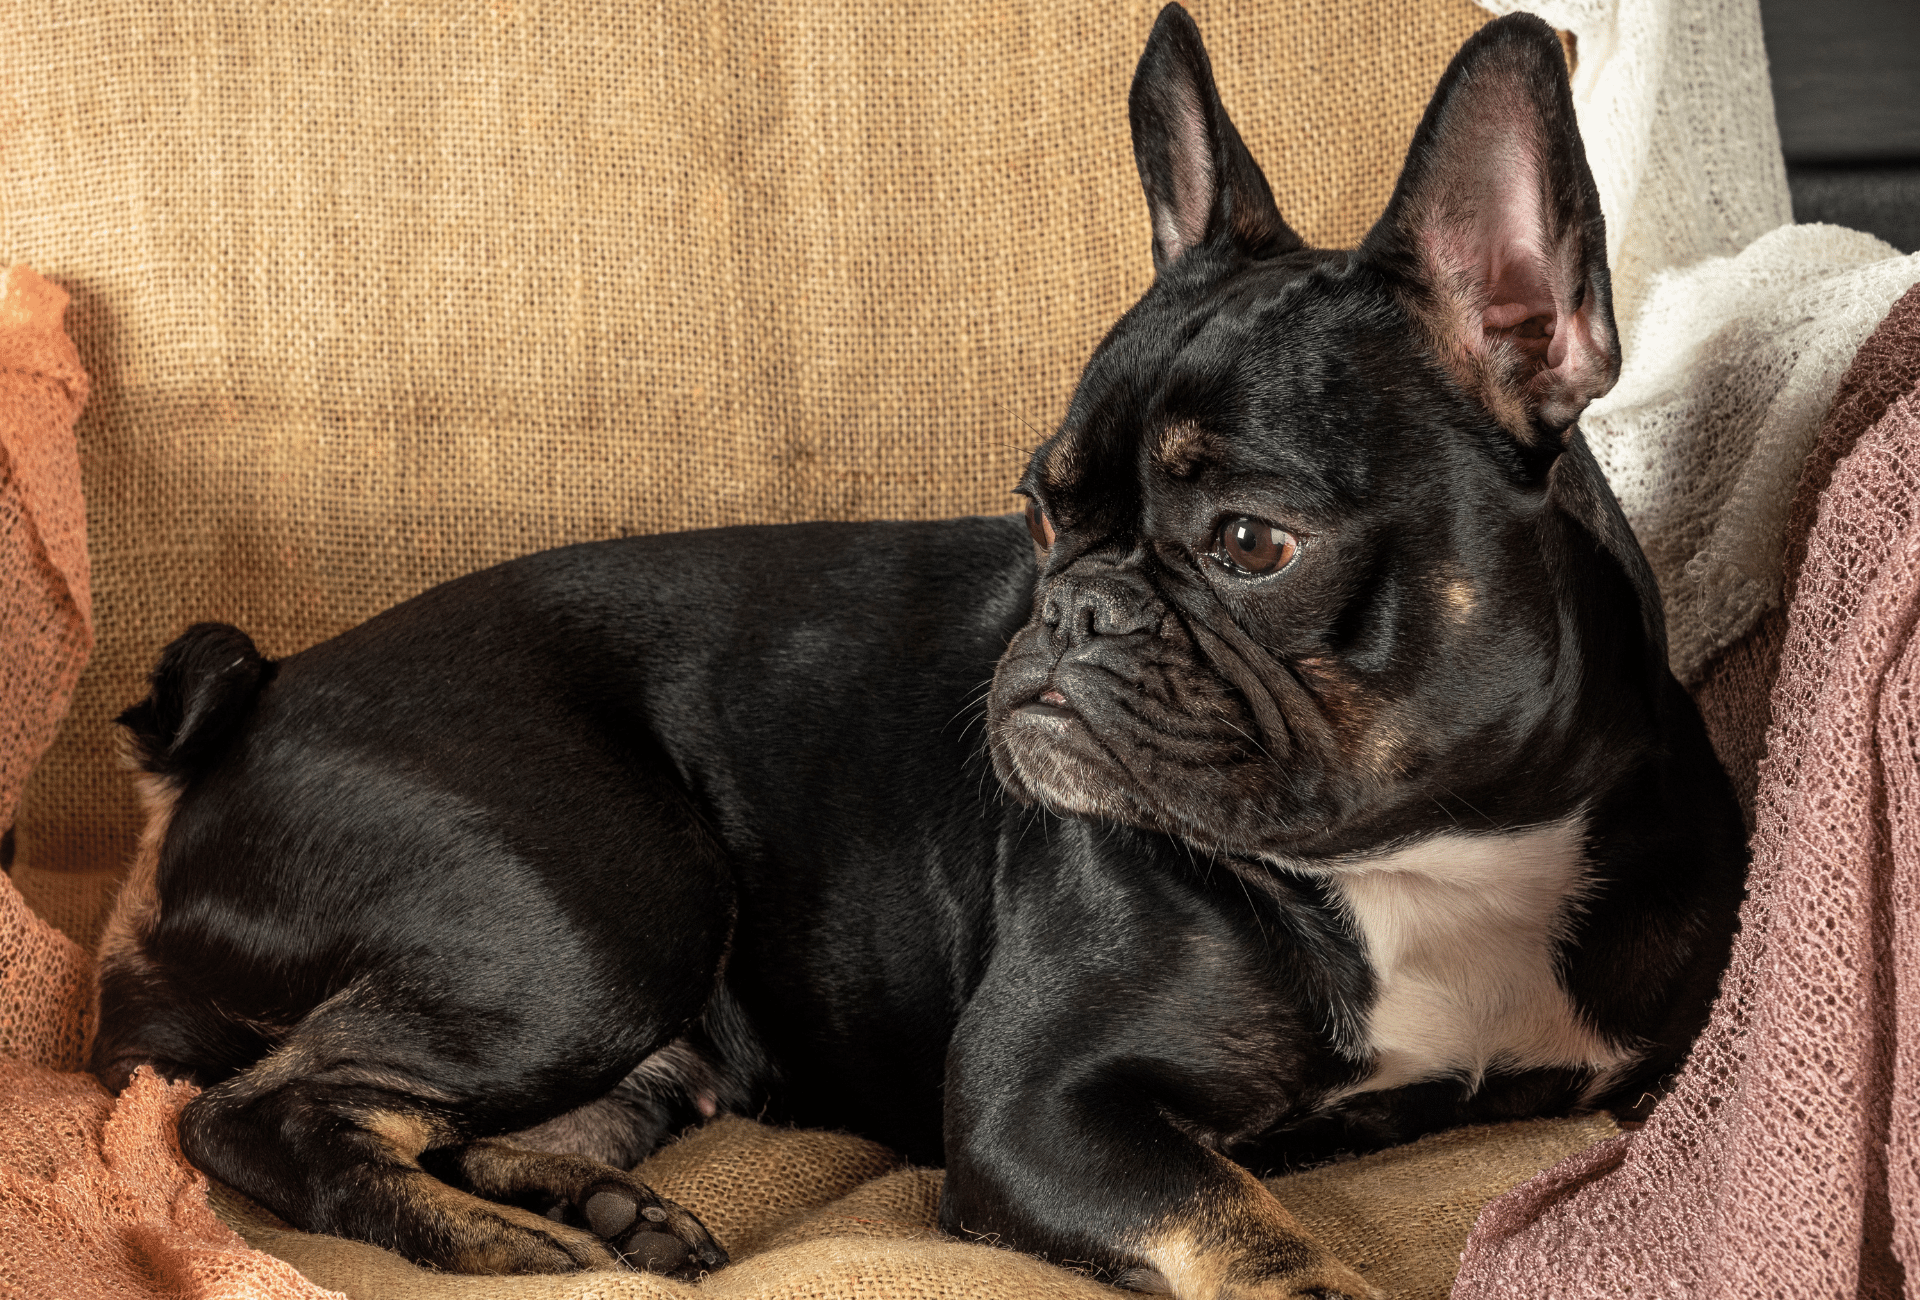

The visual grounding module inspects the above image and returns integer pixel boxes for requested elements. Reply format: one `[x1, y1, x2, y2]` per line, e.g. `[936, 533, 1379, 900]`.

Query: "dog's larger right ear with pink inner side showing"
[1359, 13, 1620, 445]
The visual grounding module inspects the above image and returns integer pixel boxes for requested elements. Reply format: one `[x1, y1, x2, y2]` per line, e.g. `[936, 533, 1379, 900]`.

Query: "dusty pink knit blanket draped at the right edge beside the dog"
[1453, 288, 1920, 1300]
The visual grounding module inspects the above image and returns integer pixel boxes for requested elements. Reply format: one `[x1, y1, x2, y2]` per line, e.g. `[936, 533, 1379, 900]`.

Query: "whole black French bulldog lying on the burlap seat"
[94, 6, 1745, 1298]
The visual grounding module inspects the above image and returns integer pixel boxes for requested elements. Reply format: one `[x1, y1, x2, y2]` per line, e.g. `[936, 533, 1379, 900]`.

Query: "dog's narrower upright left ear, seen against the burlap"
[1127, 4, 1300, 271]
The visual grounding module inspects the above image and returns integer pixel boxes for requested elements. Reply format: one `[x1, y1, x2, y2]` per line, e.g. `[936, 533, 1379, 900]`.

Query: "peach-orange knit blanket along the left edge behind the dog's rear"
[0, 267, 334, 1300]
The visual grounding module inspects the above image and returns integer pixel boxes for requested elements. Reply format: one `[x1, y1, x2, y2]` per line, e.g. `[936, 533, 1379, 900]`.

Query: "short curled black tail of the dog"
[115, 622, 275, 782]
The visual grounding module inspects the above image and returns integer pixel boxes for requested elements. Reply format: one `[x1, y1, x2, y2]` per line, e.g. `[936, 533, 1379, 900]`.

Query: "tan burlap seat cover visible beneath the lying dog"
[211, 1116, 1619, 1300]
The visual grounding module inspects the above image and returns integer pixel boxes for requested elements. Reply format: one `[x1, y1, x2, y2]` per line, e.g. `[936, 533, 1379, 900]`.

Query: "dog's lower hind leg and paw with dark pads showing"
[180, 991, 726, 1275]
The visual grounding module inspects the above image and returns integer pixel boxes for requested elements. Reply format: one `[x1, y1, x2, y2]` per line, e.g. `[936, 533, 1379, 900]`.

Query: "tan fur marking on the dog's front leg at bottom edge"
[1131, 1156, 1382, 1300]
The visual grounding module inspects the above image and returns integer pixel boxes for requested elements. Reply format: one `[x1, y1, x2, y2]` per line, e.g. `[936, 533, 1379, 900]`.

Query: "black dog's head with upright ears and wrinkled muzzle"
[989, 6, 1663, 856]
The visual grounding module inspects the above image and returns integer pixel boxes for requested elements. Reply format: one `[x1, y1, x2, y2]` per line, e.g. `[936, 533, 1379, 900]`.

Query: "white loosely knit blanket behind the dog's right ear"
[1478, 0, 1920, 684]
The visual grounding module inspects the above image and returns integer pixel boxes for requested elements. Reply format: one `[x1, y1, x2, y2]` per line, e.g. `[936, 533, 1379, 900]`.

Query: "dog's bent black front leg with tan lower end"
[941, 899, 1379, 1300]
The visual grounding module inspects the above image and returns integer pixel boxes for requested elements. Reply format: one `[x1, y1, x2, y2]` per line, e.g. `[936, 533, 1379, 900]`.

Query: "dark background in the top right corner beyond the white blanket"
[1761, 0, 1920, 253]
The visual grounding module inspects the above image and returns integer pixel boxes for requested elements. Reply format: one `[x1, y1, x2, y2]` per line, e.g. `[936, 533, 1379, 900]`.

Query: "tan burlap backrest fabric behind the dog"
[0, 0, 1486, 941]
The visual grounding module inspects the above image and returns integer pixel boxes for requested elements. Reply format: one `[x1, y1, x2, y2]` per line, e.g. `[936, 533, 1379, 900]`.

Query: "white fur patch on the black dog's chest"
[1290, 816, 1636, 1100]
